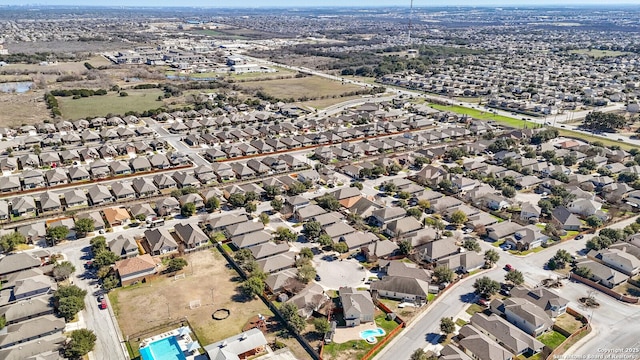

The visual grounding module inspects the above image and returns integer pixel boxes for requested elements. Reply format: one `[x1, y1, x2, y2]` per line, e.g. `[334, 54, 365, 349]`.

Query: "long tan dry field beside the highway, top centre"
[239, 76, 360, 98]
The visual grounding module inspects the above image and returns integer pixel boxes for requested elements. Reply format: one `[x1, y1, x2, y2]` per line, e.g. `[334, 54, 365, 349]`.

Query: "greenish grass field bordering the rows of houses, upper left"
[57, 89, 164, 120]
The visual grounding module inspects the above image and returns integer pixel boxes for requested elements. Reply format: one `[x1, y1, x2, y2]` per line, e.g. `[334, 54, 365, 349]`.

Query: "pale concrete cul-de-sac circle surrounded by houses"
[314, 254, 370, 290]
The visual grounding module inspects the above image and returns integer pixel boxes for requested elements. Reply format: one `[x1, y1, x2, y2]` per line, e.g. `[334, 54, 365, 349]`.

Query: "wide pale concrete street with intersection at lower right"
[374, 217, 640, 360]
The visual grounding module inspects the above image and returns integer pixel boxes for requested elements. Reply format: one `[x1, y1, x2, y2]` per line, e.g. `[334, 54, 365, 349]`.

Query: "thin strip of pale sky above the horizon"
[5, 0, 640, 8]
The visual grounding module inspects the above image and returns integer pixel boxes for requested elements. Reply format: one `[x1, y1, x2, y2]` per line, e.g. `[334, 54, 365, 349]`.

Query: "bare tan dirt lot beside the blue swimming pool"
[109, 249, 273, 352]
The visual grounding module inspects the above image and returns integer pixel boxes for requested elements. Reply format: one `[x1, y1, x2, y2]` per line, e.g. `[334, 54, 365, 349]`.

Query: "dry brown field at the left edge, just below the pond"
[0, 91, 51, 127]
